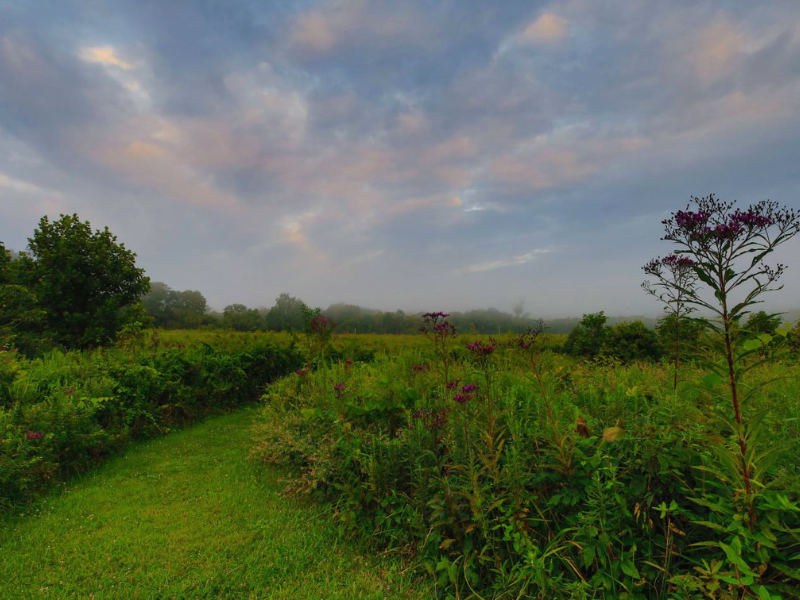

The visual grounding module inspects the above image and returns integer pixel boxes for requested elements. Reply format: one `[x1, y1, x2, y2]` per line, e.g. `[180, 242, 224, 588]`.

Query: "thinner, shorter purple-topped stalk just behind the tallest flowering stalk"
[642, 254, 697, 391]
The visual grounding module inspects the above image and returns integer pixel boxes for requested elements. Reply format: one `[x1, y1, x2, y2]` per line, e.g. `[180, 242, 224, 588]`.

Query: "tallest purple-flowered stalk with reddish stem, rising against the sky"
[662, 195, 800, 529]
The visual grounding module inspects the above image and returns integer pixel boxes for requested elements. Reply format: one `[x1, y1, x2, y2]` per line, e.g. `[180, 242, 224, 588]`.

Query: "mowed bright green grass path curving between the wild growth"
[0, 409, 431, 600]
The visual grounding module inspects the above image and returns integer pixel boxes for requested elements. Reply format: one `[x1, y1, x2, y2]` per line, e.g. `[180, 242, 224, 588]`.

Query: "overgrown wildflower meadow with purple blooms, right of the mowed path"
[255, 322, 800, 599]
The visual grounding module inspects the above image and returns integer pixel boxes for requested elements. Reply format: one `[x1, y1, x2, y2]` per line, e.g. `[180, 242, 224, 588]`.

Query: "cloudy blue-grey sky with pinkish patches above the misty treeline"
[0, 0, 800, 317]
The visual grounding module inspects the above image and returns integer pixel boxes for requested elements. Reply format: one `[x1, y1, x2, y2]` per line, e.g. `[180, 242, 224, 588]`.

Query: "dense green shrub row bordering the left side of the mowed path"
[0, 338, 302, 511]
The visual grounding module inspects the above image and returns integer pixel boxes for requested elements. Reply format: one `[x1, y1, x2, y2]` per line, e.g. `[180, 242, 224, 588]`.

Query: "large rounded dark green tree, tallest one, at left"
[19, 215, 150, 347]
